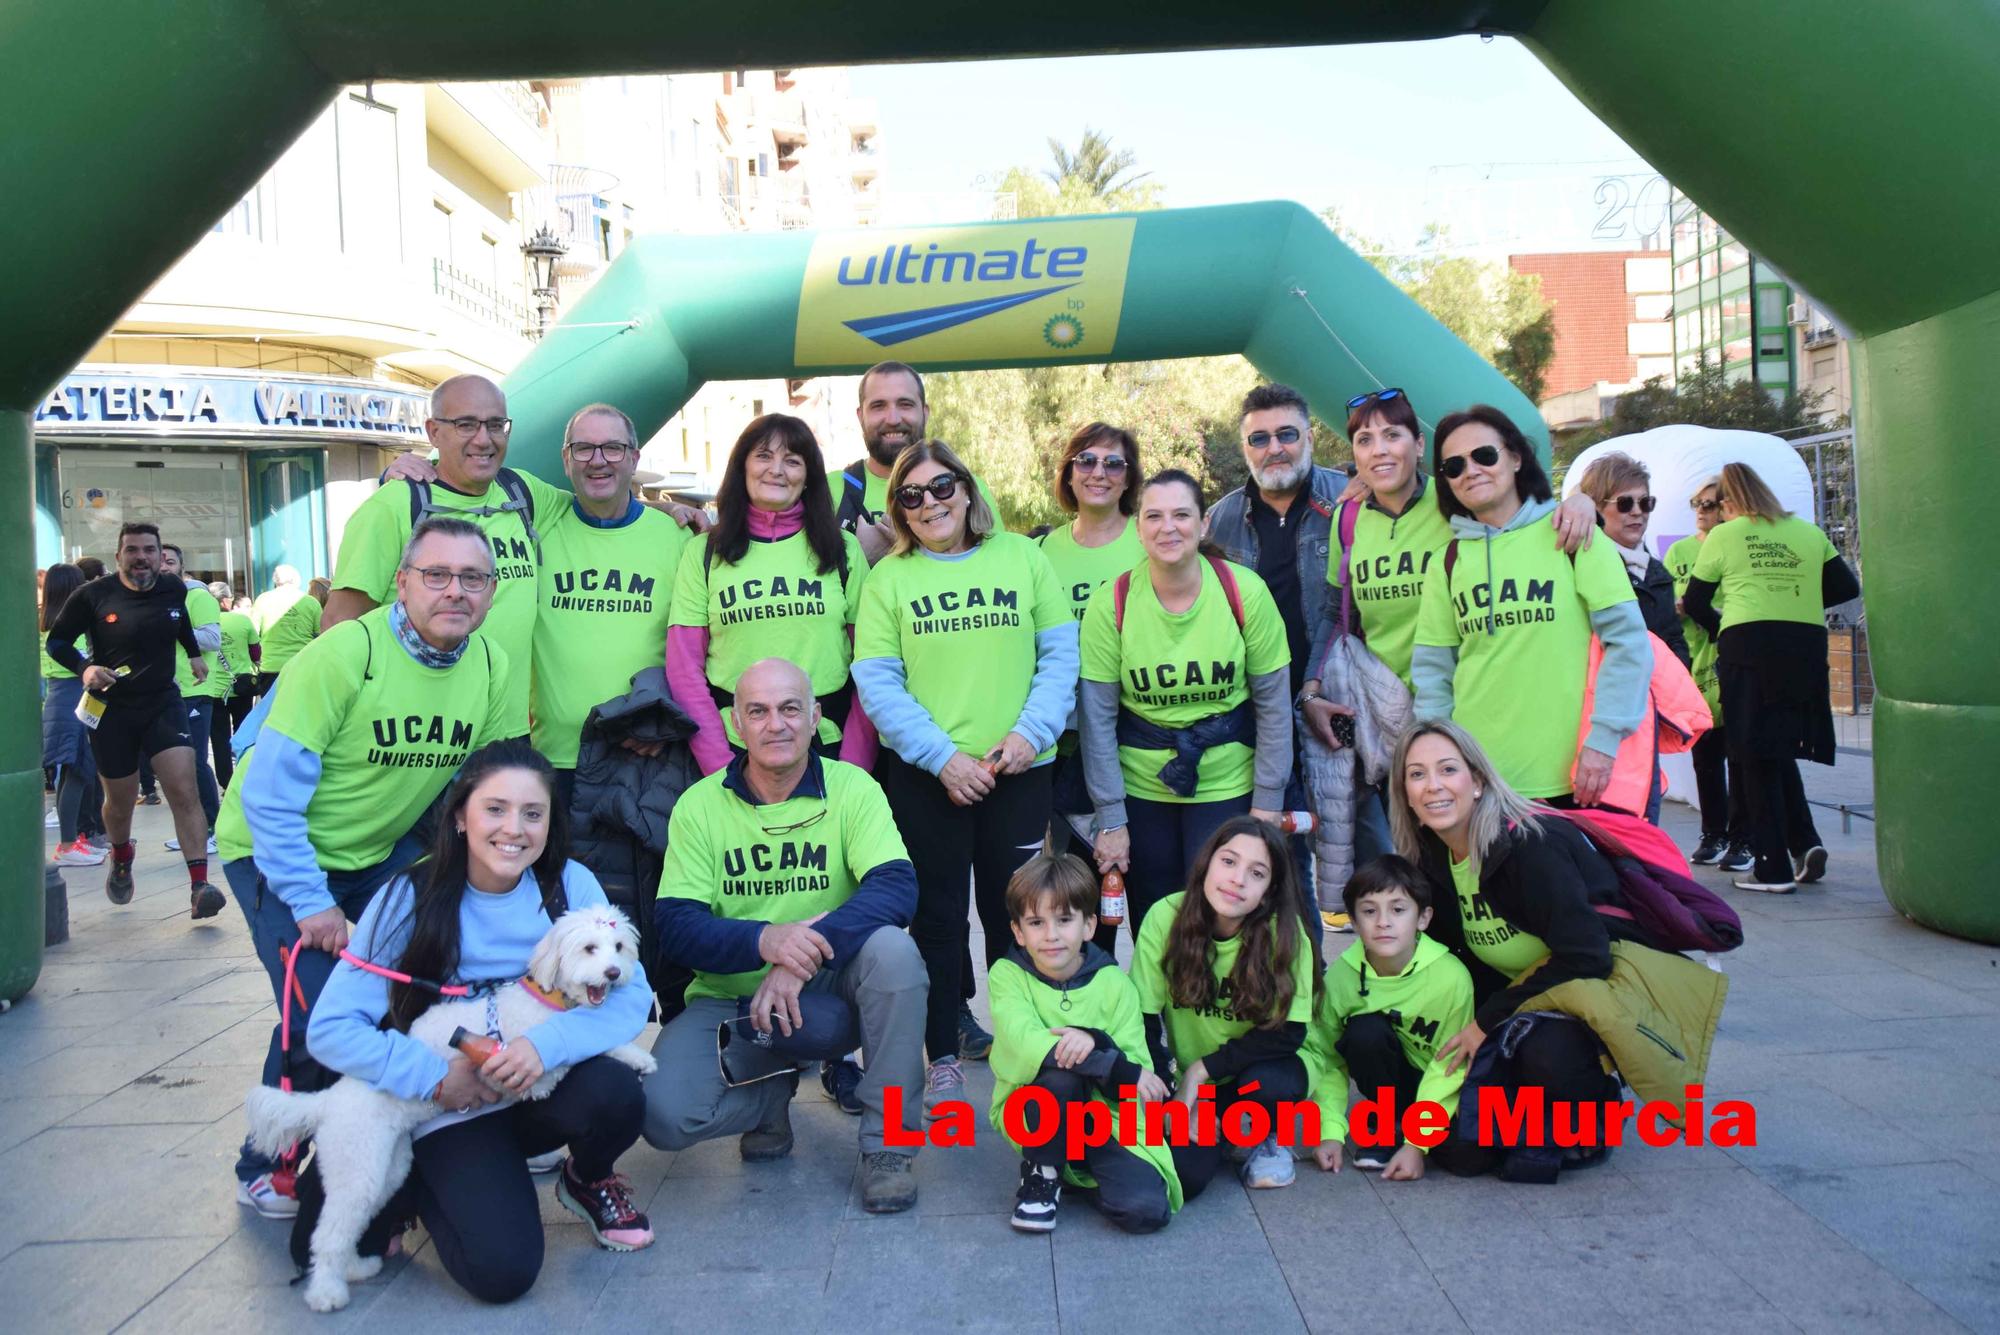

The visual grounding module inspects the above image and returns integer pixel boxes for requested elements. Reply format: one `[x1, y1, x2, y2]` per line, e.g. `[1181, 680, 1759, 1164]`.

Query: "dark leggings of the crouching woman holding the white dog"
[410, 1057, 646, 1303]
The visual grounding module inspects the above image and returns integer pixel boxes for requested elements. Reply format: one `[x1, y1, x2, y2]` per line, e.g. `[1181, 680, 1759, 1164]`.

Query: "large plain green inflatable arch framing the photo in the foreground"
[0, 0, 2000, 999]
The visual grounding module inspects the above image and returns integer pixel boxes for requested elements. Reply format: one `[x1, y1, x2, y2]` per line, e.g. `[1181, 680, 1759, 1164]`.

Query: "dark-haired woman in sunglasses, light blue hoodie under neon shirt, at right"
[1410, 404, 1652, 805]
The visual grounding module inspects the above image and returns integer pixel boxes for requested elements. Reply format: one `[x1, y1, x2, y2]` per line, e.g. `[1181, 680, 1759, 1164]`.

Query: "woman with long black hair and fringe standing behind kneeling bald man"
[666, 412, 876, 773]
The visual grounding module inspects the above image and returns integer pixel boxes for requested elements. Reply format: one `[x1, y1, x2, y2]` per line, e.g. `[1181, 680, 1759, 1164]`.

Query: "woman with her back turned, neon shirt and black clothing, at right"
[1682, 464, 1862, 895]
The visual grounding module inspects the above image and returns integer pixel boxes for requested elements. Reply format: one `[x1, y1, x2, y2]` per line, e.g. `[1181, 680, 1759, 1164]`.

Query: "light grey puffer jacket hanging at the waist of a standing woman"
[1296, 636, 1414, 909]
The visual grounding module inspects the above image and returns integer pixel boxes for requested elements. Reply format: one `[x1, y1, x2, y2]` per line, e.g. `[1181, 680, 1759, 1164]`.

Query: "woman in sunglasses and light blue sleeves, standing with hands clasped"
[854, 440, 1076, 1111]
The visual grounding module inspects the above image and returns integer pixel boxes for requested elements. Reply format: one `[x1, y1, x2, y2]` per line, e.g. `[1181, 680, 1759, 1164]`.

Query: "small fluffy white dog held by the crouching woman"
[244, 907, 654, 1311]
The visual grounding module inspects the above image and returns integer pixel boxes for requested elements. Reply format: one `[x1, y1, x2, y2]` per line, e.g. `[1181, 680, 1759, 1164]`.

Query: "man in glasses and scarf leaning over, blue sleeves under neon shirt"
[216, 516, 510, 1217]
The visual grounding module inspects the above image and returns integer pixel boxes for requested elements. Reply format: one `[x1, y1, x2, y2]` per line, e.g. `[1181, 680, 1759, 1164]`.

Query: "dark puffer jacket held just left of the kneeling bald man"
[570, 668, 702, 971]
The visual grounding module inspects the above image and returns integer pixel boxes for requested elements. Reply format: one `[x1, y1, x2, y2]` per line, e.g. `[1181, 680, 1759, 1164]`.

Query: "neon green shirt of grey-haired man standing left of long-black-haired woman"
[532, 504, 688, 769]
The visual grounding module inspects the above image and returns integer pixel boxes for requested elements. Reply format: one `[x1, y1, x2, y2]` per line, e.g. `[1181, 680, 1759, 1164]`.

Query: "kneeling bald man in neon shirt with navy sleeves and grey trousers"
[646, 658, 930, 1213]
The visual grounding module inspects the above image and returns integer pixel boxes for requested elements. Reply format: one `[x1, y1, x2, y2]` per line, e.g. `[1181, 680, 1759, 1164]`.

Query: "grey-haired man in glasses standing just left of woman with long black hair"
[534, 404, 688, 791]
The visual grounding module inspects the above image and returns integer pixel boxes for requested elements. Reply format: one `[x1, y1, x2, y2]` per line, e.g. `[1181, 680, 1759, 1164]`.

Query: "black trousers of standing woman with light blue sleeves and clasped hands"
[876, 749, 1048, 1061]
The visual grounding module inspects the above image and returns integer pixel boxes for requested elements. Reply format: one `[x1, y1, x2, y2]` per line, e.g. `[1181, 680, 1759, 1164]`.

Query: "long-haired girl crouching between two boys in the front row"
[1132, 815, 1320, 1197]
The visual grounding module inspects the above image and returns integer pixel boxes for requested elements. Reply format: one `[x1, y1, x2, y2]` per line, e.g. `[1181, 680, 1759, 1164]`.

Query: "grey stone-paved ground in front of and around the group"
[0, 755, 2000, 1335]
